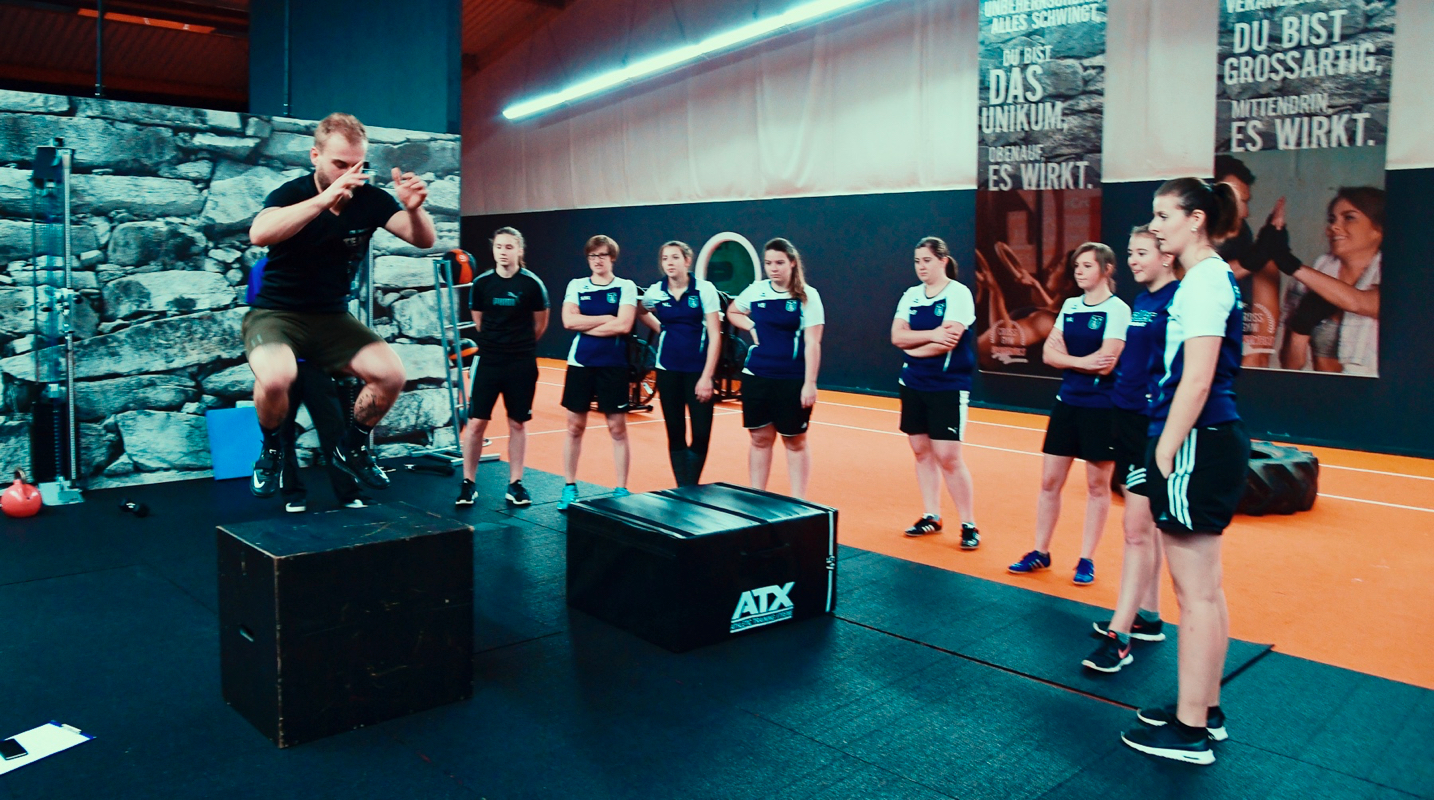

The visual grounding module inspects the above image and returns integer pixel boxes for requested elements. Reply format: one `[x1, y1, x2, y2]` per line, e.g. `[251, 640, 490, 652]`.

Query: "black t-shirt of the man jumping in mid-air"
[254, 172, 403, 314]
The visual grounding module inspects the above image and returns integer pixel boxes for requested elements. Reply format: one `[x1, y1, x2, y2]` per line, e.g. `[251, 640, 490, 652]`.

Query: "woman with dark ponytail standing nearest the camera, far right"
[1121, 178, 1250, 764]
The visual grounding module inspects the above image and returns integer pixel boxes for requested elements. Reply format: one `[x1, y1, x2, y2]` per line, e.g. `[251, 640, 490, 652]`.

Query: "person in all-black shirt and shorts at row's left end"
[453, 228, 548, 506]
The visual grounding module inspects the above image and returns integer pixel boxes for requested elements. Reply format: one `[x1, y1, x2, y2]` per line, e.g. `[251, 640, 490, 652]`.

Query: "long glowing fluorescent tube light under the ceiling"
[503, 0, 873, 119]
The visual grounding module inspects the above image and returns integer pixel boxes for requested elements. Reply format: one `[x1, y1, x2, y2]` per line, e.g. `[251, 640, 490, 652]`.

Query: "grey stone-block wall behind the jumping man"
[0, 92, 459, 487]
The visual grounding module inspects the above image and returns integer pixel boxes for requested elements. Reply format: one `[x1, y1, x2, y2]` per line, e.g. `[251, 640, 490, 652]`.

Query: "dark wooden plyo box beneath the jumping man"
[218, 503, 473, 747]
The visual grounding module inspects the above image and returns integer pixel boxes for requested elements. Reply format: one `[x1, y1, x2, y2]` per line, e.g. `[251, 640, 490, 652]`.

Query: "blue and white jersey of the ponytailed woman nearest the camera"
[1150, 257, 1245, 436]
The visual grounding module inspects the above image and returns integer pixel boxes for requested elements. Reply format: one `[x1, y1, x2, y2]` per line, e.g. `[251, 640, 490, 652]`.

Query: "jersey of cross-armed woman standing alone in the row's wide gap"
[896, 281, 977, 391]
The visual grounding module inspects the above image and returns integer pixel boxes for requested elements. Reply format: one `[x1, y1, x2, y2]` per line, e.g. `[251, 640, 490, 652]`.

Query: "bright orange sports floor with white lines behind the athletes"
[473, 360, 1434, 688]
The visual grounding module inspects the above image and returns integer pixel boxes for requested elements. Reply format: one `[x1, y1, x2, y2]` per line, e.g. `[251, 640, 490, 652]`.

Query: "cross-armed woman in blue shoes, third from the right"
[1007, 242, 1130, 586]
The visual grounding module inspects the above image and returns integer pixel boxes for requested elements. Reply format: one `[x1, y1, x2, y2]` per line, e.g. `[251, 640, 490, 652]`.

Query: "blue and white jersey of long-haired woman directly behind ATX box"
[731, 281, 826, 380]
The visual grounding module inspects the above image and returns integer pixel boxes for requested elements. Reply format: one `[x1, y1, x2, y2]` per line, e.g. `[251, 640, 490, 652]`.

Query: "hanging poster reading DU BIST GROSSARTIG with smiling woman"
[1215, 0, 1397, 377]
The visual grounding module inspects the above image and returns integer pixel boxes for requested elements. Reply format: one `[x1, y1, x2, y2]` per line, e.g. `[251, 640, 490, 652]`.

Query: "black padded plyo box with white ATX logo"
[568, 483, 836, 652]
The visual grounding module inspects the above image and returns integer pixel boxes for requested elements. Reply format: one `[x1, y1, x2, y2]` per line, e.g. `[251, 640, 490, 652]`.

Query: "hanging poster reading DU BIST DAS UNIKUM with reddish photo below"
[975, 0, 1106, 376]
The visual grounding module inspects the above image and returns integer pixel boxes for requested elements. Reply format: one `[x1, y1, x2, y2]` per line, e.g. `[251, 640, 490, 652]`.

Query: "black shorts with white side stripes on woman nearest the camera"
[1143, 420, 1250, 533]
